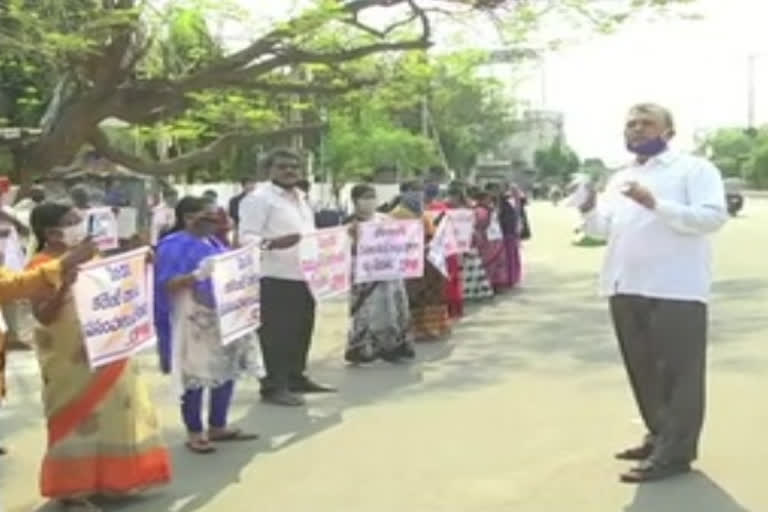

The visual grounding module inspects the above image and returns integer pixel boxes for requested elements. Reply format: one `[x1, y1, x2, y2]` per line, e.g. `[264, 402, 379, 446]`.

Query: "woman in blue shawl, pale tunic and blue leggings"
[155, 197, 257, 453]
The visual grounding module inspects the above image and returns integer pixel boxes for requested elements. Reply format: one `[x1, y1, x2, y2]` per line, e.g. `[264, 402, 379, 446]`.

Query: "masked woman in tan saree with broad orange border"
[29, 203, 171, 511]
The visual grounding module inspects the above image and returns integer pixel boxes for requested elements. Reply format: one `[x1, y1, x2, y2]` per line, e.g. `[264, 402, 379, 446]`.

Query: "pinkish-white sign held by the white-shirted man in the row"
[299, 226, 352, 300]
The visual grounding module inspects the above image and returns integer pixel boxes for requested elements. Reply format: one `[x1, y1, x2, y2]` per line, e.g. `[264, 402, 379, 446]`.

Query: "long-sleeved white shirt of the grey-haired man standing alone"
[584, 151, 728, 302]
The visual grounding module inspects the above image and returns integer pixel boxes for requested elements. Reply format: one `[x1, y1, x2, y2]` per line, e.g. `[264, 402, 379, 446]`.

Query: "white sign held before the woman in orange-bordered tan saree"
[73, 248, 155, 368]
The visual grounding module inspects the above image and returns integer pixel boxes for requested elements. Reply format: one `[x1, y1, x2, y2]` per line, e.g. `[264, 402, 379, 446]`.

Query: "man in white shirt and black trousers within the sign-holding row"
[239, 149, 333, 406]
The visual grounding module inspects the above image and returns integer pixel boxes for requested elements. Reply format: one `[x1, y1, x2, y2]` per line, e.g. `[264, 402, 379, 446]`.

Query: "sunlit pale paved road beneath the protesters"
[0, 203, 768, 512]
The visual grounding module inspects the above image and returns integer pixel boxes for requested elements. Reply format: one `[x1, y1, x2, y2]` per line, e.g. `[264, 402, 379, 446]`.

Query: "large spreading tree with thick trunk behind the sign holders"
[0, 0, 696, 180]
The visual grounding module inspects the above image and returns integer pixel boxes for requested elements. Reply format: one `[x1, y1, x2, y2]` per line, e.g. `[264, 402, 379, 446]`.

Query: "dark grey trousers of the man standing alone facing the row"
[610, 295, 707, 463]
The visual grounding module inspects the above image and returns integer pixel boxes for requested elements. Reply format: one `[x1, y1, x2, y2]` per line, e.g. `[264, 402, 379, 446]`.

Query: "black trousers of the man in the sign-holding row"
[259, 277, 315, 394]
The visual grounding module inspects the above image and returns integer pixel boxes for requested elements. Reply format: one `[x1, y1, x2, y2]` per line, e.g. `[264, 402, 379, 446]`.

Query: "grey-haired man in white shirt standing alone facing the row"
[581, 104, 728, 483]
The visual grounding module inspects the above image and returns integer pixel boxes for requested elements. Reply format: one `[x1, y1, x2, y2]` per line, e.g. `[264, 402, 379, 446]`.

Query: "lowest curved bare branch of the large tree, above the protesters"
[89, 123, 327, 176]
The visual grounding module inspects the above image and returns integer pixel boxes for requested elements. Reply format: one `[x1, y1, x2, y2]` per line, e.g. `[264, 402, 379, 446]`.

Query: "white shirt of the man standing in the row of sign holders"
[238, 183, 315, 281]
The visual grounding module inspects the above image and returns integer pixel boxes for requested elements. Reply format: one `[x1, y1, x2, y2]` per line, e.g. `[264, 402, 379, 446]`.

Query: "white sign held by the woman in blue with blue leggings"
[211, 244, 261, 345]
